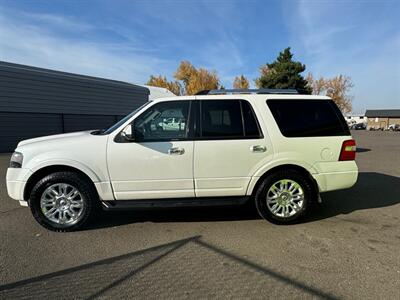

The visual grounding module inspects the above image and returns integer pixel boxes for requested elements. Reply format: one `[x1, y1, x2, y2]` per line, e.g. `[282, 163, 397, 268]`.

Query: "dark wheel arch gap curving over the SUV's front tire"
[24, 164, 97, 201]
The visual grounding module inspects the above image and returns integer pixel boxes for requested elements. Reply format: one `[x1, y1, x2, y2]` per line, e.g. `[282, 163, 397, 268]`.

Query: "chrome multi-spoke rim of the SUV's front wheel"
[40, 183, 85, 226]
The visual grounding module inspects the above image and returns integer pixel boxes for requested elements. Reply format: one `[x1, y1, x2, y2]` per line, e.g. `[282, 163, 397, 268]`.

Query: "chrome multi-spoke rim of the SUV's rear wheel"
[267, 179, 304, 218]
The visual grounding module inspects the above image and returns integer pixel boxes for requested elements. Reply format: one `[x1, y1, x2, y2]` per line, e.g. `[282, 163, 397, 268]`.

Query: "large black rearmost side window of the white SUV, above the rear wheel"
[267, 100, 350, 137]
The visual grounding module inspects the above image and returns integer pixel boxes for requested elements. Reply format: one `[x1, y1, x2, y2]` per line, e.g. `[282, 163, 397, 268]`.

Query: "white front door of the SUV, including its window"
[107, 100, 194, 200]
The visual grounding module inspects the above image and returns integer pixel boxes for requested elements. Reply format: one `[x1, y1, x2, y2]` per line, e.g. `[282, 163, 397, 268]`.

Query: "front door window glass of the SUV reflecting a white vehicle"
[133, 101, 189, 142]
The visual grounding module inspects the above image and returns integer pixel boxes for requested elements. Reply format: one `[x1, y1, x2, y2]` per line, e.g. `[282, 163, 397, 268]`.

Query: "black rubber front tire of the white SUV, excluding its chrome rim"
[29, 172, 99, 232]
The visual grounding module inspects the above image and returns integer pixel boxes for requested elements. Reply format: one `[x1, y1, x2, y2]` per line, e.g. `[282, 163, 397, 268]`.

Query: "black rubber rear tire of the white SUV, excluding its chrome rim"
[255, 169, 316, 224]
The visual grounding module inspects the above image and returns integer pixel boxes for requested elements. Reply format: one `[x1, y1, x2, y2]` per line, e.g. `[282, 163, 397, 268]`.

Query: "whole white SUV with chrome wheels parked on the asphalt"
[7, 90, 358, 231]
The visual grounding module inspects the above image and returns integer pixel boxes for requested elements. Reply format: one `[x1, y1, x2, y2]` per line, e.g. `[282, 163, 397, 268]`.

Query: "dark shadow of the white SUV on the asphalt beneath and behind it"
[85, 172, 400, 230]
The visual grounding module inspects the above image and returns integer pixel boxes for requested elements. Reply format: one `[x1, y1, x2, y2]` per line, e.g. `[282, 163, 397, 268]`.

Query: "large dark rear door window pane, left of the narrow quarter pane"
[201, 100, 243, 138]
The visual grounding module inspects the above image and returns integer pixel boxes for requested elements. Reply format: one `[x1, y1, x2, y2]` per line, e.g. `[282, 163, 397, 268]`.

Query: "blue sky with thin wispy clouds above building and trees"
[0, 0, 400, 113]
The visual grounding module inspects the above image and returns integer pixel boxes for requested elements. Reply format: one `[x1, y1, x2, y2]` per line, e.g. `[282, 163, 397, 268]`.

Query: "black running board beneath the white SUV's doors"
[102, 197, 250, 210]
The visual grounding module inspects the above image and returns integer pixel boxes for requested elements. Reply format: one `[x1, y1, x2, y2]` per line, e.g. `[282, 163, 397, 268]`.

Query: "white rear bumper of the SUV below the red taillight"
[312, 161, 358, 193]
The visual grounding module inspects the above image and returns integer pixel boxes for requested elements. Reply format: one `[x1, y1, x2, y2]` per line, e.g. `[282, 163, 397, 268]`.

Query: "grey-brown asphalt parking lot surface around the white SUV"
[0, 131, 400, 299]
